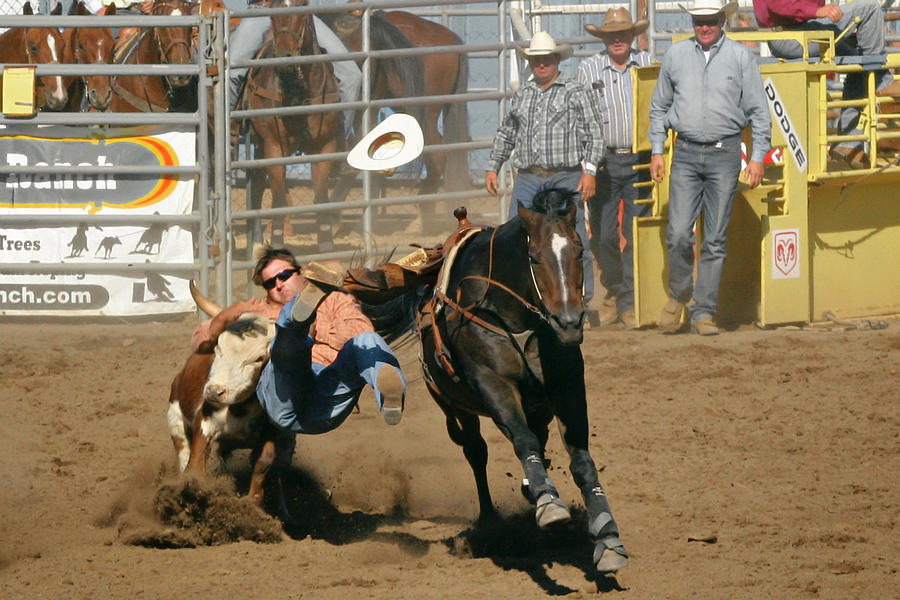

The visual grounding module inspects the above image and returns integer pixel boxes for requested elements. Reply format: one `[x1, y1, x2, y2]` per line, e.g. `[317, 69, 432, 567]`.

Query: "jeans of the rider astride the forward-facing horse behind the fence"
[228, 10, 362, 132]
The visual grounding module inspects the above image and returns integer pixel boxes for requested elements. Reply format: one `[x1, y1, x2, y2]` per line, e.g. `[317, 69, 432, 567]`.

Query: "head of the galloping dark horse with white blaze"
[519, 189, 585, 345]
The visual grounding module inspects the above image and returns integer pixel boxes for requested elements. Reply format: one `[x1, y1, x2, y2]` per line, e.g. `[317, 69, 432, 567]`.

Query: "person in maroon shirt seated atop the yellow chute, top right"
[753, 0, 894, 169]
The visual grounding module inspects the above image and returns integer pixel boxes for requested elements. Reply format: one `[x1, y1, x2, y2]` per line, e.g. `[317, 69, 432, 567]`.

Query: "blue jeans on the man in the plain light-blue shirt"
[666, 134, 741, 323]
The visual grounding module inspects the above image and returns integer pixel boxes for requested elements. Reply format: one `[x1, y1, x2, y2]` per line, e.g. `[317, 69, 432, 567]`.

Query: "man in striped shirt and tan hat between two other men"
[578, 8, 650, 329]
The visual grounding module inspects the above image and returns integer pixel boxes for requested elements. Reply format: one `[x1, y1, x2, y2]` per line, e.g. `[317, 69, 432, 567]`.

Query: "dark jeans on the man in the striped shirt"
[588, 152, 650, 314]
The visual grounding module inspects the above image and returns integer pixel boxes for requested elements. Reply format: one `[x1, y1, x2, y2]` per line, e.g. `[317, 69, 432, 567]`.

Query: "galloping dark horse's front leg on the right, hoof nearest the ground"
[544, 347, 628, 573]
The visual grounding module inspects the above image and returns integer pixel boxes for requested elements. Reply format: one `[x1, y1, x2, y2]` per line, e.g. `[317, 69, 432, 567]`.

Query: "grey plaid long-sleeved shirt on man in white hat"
[487, 74, 606, 175]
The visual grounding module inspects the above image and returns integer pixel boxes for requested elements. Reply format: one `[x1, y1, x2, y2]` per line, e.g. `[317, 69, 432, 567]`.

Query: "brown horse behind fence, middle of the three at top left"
[63, 2, 116, 112]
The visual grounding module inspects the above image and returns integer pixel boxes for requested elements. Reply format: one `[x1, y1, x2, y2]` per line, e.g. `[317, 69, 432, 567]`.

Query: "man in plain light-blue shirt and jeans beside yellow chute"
[649, 0, 772, 335]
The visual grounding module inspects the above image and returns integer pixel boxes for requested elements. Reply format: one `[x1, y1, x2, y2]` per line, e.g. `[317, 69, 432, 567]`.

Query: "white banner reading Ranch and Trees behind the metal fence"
[0, 127, 196, 316]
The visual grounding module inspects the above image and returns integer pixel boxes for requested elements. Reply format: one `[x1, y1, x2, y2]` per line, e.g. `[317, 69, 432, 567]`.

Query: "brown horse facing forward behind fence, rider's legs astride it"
[241, 0, 344, 248]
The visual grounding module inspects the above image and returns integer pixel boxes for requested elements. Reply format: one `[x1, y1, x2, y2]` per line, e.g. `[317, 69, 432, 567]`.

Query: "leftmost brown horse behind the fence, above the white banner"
[0, 3, 69, 110]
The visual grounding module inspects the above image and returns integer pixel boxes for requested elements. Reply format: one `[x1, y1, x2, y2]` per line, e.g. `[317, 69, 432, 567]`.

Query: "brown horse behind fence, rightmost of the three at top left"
[112, 0, 193, 112]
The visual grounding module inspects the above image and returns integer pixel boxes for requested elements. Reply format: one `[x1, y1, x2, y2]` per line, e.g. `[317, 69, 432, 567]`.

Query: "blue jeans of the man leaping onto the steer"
[256, 301, 406, 434]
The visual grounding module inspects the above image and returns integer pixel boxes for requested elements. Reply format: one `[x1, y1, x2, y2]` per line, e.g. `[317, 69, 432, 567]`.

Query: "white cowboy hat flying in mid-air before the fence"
[347, 113, 425, 174]
